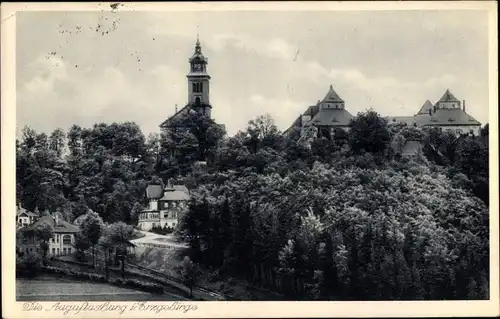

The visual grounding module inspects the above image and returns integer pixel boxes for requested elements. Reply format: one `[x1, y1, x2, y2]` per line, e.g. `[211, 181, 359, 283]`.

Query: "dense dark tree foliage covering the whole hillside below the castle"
[16, 111, 489, 300]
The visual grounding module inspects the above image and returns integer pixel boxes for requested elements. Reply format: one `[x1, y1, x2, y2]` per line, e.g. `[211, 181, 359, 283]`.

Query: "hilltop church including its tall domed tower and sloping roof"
[160, 37, 212, 130]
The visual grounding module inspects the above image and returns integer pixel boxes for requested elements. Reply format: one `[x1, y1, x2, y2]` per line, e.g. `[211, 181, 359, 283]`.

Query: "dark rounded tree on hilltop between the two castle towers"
[349, 110, 391, 154]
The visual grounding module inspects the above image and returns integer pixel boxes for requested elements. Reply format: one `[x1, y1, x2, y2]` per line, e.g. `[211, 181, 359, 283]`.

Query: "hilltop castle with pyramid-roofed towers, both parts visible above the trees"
[285, 85, 481, 137]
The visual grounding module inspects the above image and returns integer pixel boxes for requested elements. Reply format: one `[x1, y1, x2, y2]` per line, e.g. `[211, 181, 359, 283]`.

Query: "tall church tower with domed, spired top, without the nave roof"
[187, 36, 212, 118]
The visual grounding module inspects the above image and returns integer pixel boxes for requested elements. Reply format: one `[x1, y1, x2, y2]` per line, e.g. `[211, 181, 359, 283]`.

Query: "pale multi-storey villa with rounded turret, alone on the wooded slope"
[137, 181, 189, 231]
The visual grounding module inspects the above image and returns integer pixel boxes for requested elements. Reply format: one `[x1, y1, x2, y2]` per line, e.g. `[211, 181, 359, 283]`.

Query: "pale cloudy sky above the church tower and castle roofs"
[16, 10, 489, 136]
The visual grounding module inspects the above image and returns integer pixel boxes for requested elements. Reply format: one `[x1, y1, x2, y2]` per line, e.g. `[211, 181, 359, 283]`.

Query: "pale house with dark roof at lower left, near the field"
[16, 212, 80, 256]
